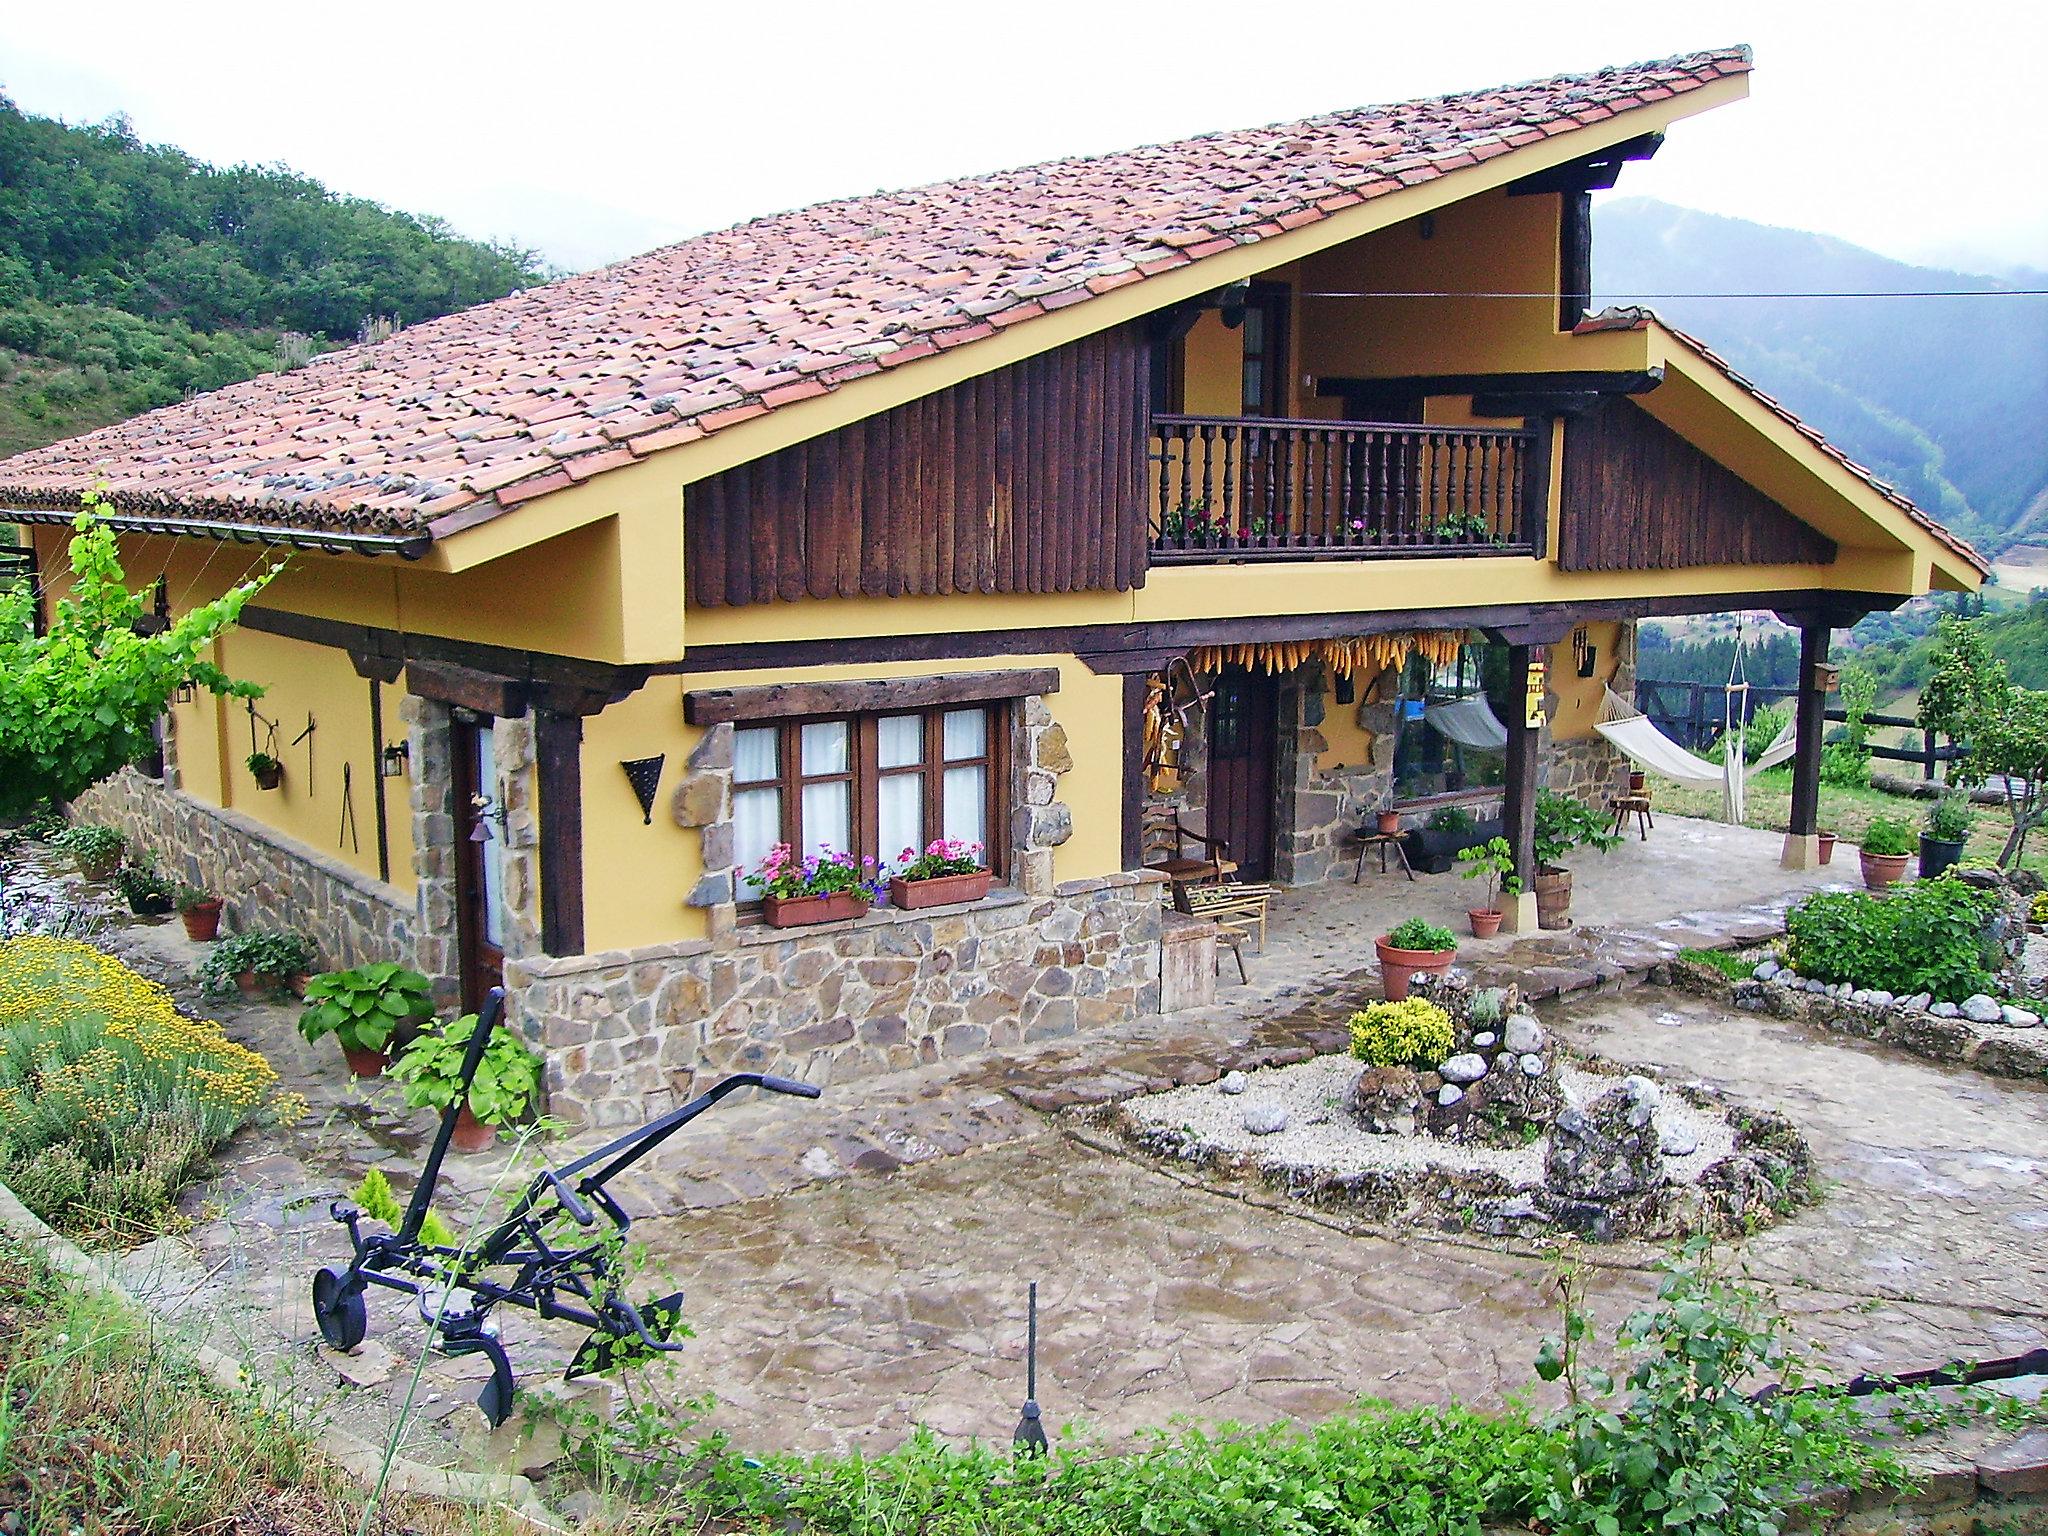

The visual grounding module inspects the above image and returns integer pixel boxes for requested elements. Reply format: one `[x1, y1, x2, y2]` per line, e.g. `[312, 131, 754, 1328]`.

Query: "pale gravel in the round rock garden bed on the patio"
[1120, 1055, 1735, 1188]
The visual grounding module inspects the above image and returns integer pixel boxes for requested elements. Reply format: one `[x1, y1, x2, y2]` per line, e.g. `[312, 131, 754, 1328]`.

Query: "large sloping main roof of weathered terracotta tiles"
[0, 47, 1749, 535]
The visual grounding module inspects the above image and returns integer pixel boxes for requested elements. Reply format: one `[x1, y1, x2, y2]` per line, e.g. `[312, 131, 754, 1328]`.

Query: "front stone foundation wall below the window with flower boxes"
[506, 874, 1161, 1126]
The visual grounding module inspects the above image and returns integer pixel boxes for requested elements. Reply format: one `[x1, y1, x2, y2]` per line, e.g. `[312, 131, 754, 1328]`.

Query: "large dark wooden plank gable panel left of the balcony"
[684, 326, 1149, 606]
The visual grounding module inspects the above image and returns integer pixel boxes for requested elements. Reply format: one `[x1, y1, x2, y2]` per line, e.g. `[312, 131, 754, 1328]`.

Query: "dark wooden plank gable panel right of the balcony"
[1556, 399, 1835, 571]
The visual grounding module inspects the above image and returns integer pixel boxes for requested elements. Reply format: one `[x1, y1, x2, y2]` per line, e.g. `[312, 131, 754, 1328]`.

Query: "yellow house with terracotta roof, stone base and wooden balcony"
[0, 49, 1985, 1124]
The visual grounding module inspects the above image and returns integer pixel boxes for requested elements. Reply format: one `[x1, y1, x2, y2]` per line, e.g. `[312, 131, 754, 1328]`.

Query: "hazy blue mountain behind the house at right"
[1593, 197, 2048, 551]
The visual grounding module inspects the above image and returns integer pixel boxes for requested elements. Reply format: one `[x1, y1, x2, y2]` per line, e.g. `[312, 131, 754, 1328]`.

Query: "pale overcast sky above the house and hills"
[0, 0, 2048, 270]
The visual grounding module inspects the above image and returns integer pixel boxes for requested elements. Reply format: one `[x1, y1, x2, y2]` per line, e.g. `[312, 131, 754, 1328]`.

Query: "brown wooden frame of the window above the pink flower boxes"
[731, 700, 1012, 879]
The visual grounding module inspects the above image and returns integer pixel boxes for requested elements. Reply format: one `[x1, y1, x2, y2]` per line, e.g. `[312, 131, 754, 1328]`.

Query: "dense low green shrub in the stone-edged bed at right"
[1786, 879, 1999, 1004]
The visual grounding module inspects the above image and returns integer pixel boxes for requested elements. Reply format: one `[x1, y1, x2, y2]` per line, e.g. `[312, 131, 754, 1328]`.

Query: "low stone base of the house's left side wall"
[72, 768, 420, 967]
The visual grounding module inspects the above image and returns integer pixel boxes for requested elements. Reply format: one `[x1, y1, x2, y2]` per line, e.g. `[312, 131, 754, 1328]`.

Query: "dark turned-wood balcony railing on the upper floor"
[1151, 416, 1550, 563]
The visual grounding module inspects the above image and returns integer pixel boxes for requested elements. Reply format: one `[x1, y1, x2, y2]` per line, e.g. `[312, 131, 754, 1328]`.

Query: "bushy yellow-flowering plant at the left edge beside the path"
[0, 936, 303, 1233]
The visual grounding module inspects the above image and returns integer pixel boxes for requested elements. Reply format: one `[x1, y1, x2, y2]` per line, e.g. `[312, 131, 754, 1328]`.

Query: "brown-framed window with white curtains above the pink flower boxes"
[733, 705, 1008, 889]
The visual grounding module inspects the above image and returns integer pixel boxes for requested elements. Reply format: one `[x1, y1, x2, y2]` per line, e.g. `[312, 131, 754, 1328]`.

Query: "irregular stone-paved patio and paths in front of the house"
[8, 819, 2048, 1458]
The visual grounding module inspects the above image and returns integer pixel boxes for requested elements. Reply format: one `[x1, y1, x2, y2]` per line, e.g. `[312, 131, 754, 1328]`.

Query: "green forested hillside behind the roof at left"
[0, 96, 541, 457]
